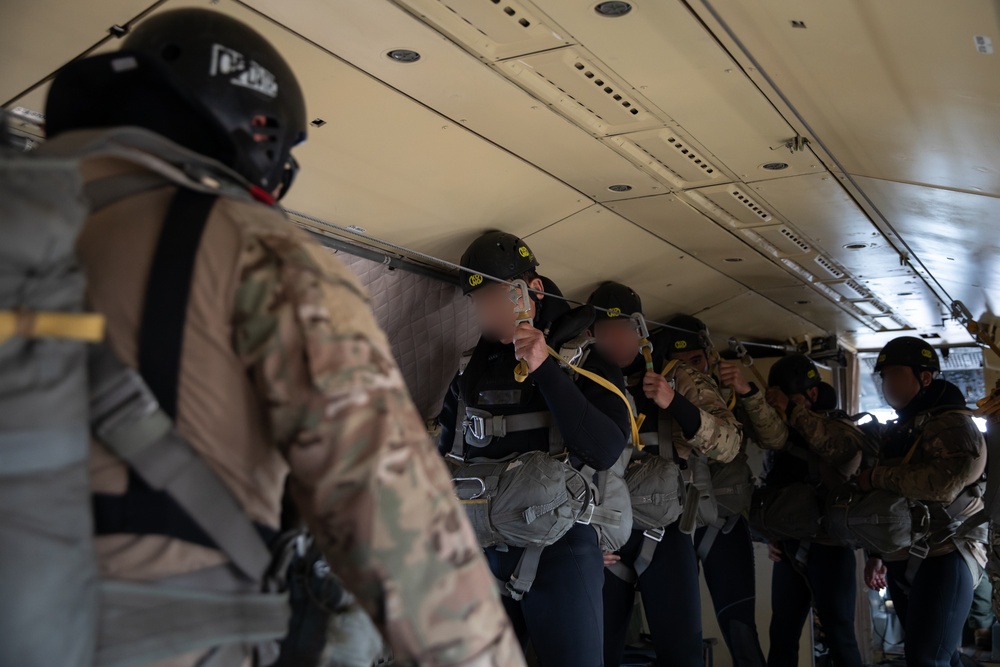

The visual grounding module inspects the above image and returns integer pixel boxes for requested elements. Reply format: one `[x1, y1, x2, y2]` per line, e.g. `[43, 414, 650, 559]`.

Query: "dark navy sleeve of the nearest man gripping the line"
[532, 354, 630, 470]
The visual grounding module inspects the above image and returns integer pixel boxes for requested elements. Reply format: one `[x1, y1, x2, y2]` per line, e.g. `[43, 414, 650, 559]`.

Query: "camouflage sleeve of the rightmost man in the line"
[872, 413, 986, 503]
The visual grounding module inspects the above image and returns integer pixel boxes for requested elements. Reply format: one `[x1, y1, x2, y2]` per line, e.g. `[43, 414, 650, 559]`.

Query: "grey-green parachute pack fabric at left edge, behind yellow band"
[0, 149, 103, 667]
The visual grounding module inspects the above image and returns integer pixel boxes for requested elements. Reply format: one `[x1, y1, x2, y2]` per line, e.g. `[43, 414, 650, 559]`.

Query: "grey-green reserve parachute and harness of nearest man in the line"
[447, 318, 636, 600]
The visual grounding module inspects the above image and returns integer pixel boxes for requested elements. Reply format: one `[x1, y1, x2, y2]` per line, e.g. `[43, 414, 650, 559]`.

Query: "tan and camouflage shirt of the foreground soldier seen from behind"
[59, 131, 523, 667]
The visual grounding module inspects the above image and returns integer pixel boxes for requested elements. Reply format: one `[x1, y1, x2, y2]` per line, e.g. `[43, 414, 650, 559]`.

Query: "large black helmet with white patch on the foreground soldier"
[45, 8, 306, 191]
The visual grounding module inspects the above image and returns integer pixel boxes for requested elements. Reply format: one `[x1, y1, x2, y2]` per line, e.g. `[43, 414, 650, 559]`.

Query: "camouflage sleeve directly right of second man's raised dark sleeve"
[674, 366, 743, 463]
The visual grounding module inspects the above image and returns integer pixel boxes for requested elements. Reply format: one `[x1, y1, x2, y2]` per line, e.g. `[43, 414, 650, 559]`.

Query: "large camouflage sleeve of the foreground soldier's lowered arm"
[233, 231, 523, 667]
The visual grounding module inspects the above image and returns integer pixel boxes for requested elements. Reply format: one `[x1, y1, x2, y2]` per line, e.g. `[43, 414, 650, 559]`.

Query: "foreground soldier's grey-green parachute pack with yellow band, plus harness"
[0, 128, 381, 667]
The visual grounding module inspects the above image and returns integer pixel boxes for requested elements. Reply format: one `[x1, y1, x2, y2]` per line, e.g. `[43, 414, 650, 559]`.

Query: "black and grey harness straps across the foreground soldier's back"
[91, 189, 271, 581]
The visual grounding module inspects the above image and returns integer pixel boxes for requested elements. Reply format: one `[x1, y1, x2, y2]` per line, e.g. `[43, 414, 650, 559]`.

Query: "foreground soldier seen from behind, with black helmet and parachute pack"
[0, 9, 523, 667]
